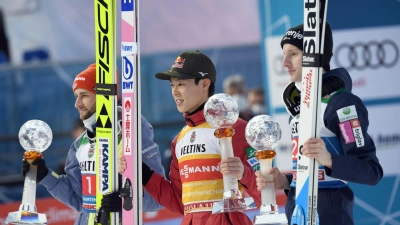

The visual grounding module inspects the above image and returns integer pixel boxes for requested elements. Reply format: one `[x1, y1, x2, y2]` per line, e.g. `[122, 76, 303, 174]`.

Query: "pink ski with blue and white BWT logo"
[121, 0, 143, 225]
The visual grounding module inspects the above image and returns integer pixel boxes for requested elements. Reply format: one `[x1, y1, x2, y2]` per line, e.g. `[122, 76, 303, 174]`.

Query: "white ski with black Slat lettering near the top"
[291, 0, 328, 225]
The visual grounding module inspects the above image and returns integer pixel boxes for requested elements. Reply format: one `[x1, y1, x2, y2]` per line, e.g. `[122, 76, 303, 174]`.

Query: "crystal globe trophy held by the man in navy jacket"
[245, 115, 288, 224]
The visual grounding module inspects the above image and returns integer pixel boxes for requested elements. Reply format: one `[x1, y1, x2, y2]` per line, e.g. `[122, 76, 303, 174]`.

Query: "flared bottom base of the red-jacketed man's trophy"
[212, 197, 257, 214]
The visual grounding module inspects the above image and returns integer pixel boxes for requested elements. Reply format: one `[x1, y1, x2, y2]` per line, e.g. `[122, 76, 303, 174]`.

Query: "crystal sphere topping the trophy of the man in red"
[204, 93, 239, 128]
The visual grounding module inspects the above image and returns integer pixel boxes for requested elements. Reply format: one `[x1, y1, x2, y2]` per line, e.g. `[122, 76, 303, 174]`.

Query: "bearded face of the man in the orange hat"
[74, 88, 96, 120]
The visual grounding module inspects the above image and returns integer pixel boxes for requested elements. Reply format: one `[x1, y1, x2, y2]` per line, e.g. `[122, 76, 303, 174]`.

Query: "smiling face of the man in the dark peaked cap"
[170, 77, 211, 113]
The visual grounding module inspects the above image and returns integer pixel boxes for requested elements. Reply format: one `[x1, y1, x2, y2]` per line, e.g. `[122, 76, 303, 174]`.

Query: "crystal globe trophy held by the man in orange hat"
[6, 120, 53, 224]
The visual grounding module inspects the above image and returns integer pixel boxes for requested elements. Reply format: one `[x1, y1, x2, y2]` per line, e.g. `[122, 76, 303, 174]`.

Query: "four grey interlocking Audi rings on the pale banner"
[333, 40, 399, 70]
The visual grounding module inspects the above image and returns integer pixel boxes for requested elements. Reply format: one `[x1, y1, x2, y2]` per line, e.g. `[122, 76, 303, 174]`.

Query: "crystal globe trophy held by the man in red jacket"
[204, 94, 256, 214]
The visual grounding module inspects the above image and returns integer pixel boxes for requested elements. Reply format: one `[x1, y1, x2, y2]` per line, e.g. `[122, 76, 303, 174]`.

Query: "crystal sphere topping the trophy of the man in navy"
[245, 115, 282, 150]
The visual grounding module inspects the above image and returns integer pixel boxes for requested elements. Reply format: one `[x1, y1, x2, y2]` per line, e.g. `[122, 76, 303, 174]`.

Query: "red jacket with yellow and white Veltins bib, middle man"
[145, 108, 261, 225]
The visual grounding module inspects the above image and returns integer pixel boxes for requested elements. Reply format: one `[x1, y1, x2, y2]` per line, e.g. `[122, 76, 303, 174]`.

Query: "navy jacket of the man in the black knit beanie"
[285, 68, 383, 225]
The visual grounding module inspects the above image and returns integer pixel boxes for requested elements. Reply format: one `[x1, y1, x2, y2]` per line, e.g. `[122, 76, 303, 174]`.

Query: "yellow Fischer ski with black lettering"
[95, 0, 119, 225]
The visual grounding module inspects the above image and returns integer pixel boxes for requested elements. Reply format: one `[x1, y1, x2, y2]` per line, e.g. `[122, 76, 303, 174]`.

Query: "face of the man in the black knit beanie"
[282, 44, 303, 82]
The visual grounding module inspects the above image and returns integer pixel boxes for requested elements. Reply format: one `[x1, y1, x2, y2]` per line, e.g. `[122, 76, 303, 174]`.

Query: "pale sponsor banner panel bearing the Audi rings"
[331, 25, 400, 100]
